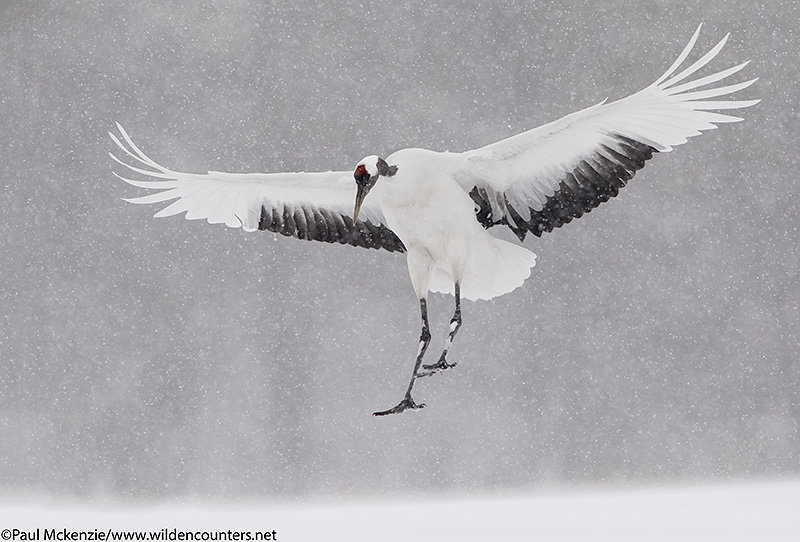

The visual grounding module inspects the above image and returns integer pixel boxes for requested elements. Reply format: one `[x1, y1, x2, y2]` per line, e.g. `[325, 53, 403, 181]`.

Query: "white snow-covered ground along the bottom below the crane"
[0, 481, 800, 542]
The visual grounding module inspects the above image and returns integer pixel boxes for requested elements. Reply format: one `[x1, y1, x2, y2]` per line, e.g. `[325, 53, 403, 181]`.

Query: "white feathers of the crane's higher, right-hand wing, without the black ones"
[457, 25, 759, 234]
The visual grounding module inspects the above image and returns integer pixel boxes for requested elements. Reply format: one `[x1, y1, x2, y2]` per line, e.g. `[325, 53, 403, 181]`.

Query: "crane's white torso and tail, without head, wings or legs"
[371, 149, 536, 300]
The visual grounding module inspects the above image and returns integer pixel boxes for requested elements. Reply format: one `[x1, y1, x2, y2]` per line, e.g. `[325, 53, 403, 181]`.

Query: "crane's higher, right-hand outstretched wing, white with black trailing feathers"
[457, 25, 759, 240]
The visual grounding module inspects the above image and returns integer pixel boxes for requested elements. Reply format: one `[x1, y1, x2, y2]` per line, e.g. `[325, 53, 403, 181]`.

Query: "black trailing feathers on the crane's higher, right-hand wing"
[470, 135, 658, 241]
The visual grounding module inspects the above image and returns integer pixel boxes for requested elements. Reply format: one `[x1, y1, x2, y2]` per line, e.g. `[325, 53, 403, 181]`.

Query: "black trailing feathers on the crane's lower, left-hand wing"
[258, 206, 406, 252]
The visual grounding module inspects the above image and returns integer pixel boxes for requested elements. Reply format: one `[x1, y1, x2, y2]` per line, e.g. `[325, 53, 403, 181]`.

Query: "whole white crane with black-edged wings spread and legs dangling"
[111, 27, 758, 415]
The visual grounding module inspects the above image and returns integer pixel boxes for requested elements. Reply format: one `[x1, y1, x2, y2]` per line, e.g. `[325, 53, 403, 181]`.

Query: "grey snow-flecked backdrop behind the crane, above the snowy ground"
[0, 0, 800, 502]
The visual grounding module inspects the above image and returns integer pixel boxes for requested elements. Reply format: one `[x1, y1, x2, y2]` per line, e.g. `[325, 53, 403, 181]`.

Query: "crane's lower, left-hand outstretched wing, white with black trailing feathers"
[109, 124, 405, 252]
